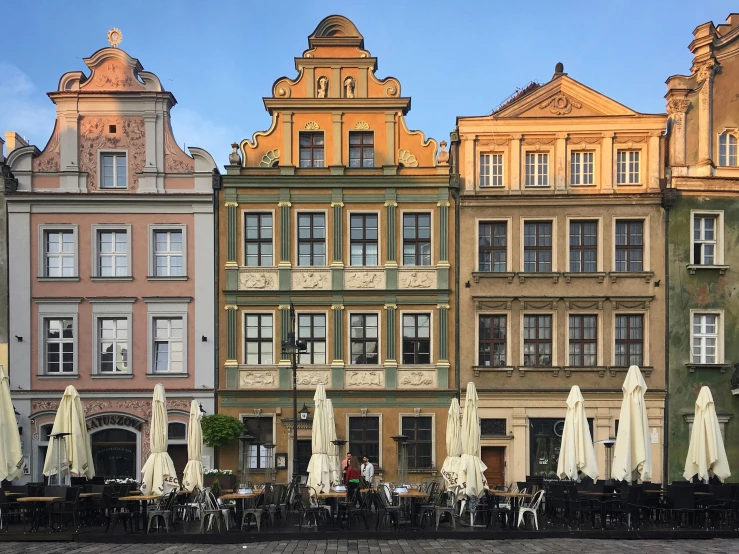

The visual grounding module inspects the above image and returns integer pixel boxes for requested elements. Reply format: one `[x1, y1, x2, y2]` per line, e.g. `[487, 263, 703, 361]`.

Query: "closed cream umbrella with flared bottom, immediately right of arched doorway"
[141, 384, 179, 496]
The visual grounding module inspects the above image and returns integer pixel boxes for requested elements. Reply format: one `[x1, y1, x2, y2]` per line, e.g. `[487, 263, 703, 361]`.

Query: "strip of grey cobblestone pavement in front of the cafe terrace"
[0, 539, 739, 554]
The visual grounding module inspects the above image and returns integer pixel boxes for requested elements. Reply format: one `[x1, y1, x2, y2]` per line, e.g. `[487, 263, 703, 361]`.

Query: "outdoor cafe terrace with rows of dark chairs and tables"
[0, 477, 739, 543]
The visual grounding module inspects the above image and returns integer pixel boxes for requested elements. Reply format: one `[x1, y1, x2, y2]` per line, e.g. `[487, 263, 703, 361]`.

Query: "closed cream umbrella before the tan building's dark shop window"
[557, 385, 600, 481]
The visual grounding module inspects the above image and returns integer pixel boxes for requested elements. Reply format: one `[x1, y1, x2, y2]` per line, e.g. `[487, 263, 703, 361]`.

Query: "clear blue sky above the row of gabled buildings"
[0, 0, 738, 164]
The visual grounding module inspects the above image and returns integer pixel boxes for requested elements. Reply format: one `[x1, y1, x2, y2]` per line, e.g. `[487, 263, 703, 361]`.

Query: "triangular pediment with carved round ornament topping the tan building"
[493, 75, 638, 118]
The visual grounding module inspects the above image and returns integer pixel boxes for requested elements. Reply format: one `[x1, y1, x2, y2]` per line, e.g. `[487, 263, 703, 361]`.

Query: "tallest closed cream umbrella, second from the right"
[611, 365, 652, 481]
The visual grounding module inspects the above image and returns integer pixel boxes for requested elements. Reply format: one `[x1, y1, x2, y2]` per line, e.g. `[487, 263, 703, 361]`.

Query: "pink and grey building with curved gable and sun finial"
[6, 42, 218, 480]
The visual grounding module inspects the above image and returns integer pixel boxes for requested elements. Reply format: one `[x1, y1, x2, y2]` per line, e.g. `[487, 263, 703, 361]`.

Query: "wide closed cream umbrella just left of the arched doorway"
[44, 385, 95, 479]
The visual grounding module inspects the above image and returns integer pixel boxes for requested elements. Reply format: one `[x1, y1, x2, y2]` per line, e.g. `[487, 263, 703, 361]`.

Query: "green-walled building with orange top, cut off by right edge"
[665, 14, 739, 480]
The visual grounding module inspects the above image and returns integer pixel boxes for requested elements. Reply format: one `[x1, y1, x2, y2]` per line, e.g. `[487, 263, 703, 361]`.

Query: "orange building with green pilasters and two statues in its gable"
[218, 16, 455, 481]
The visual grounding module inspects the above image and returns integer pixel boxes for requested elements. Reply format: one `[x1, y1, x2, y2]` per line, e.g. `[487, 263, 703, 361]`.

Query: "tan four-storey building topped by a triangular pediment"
[452, 64, 666, 485]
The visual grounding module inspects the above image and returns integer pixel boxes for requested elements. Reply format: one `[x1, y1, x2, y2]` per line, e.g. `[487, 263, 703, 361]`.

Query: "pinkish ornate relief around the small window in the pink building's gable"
[79, 116, 146, 192]
